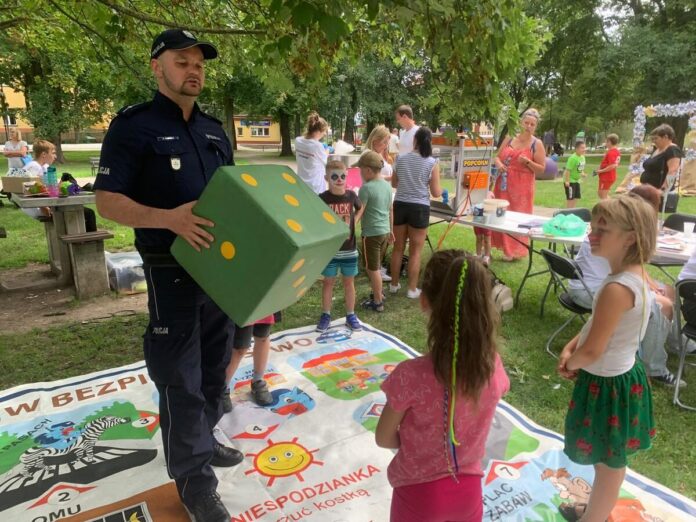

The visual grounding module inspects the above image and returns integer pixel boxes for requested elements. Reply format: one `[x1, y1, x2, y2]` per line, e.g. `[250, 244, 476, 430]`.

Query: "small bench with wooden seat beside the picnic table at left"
[60, 230, 114, 299]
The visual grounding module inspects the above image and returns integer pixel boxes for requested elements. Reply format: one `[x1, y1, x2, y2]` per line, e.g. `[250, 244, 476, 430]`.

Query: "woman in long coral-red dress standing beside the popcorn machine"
[491, 109, 546, 261]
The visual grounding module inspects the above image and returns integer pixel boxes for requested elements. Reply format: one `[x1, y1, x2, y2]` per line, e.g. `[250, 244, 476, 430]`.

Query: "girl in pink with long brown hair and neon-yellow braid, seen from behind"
[376, 250, 510, 522]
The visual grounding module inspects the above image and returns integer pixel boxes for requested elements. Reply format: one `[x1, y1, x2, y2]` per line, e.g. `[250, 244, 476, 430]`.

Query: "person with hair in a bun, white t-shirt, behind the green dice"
[295, 112, 329, 194]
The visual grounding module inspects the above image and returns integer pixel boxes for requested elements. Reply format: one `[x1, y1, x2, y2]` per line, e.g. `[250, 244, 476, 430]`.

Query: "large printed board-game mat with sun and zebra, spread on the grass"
[0, 322, 696, 522]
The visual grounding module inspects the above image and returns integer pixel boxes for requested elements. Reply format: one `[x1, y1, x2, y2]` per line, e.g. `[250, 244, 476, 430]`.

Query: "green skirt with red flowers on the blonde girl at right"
[563, 361, 655, 468]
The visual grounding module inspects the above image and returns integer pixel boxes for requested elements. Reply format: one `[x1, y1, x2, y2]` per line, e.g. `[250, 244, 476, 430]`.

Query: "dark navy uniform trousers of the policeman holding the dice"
[143, 261, 234, 501]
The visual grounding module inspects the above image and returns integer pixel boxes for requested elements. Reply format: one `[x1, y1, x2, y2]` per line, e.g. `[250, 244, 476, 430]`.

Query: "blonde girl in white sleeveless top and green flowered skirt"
[558, 196, 657, 522]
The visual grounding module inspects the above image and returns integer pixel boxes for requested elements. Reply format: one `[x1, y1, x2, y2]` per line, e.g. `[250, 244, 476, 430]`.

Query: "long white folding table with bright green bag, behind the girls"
[430, 201, 696, 305]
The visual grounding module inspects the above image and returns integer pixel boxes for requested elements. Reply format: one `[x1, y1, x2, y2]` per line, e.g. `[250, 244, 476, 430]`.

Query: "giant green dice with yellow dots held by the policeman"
[171, 165, 350, 325]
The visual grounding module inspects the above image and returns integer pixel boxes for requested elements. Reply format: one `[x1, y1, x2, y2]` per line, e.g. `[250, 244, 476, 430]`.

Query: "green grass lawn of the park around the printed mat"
[0, 150, 696, 498]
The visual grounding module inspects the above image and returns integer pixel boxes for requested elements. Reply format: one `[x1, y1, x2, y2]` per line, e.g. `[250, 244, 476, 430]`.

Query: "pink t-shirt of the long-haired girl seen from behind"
[382, 355, 510, 488]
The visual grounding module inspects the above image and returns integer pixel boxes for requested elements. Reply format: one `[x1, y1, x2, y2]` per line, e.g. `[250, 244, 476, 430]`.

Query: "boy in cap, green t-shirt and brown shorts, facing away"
[356, 151, 394, 312]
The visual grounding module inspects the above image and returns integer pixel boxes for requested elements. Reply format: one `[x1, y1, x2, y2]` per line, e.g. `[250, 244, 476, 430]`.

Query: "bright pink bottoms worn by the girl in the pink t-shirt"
[390, 475, 483, 522]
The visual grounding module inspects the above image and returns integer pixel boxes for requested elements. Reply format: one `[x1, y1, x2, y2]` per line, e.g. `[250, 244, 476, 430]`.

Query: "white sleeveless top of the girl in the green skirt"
[578, 272, 654, 377]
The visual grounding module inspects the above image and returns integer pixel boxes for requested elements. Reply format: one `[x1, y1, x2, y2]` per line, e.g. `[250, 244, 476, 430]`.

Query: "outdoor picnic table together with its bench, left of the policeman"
[5, 192, 113, 299]
